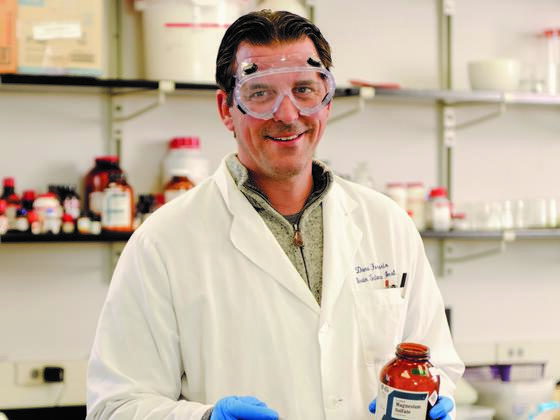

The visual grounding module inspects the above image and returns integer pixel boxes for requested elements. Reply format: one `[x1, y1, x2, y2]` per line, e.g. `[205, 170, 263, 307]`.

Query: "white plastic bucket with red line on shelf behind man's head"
[135, 0, 246, 83]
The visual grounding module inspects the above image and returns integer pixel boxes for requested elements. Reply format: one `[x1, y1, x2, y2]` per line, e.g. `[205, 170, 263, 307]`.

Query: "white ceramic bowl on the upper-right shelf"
[468, 59, 521, 91]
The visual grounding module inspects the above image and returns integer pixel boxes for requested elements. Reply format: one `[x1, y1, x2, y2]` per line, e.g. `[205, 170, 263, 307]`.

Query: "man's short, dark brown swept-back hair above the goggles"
[216, 9, 332, 106]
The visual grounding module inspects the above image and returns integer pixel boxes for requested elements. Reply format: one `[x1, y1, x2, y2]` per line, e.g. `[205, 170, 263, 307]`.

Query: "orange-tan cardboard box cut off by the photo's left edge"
[0, 0, 17, 73]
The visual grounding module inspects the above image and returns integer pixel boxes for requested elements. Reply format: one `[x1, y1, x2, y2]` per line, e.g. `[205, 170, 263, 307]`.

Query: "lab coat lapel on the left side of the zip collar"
[215, 160, 319, 313]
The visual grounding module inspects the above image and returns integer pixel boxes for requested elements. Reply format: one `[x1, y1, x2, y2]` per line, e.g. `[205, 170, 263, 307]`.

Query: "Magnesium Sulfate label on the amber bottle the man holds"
[375, 383, 437, 420]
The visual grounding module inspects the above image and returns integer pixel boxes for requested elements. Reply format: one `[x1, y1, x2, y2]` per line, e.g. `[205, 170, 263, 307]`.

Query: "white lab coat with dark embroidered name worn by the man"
[88, 157, 463, 420]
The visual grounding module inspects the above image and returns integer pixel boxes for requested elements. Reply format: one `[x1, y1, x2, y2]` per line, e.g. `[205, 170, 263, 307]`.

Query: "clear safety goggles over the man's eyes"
[233, 54, 335, 120]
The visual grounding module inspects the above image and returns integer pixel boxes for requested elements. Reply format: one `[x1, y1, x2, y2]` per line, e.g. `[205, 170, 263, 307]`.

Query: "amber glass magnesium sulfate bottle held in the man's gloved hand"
[375, 343, 439, 420]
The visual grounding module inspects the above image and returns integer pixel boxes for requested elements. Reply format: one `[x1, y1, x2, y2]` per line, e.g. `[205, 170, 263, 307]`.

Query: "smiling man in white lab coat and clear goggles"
[88, 11, 463, 420]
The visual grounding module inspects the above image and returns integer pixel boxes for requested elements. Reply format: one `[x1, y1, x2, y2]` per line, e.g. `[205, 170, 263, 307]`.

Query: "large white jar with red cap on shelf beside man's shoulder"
[162, 136, 208, 185]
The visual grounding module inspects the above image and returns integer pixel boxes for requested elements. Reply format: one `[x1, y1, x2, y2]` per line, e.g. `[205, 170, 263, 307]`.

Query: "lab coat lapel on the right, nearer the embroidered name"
[320, 183, 363, 325]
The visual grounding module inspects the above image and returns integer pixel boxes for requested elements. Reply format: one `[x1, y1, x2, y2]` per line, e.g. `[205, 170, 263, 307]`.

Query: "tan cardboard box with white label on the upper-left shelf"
[18, 0, 104, 76]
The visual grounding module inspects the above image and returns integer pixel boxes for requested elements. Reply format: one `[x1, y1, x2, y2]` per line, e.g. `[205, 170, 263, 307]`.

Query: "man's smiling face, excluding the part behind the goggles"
[218, 38, 331, 180]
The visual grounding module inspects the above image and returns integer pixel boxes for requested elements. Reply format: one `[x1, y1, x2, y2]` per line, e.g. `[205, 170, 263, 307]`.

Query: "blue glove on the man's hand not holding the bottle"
[210, 397, 278, 420]
